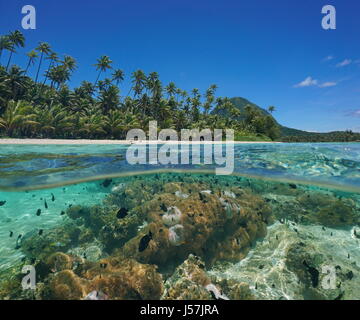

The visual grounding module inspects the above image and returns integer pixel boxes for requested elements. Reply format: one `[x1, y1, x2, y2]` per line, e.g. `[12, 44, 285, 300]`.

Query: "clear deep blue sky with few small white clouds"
[0, 0, 360, 132]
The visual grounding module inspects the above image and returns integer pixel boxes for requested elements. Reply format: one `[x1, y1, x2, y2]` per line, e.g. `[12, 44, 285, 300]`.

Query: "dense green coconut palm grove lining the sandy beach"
[0, 31, 280, 140]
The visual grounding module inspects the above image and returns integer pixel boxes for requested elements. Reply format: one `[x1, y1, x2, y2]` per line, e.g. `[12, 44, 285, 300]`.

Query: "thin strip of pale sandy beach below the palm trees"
[0, 138, 283, 145]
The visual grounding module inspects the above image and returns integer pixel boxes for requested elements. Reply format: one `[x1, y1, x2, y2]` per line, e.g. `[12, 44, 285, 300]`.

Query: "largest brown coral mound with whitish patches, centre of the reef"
[120, 184, 271, 267]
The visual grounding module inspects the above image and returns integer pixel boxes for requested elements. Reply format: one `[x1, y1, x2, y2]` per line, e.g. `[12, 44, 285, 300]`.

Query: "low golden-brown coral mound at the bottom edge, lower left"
[39, 258, 163, 300]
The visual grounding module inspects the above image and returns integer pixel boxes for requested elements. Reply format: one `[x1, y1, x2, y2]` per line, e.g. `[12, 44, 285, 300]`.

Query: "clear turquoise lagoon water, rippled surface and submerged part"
[0, 143, 360, 299]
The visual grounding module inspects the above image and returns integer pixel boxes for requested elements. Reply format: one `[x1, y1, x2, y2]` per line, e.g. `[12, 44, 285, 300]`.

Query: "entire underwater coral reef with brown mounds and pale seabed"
[0, 174, 360, 300]
